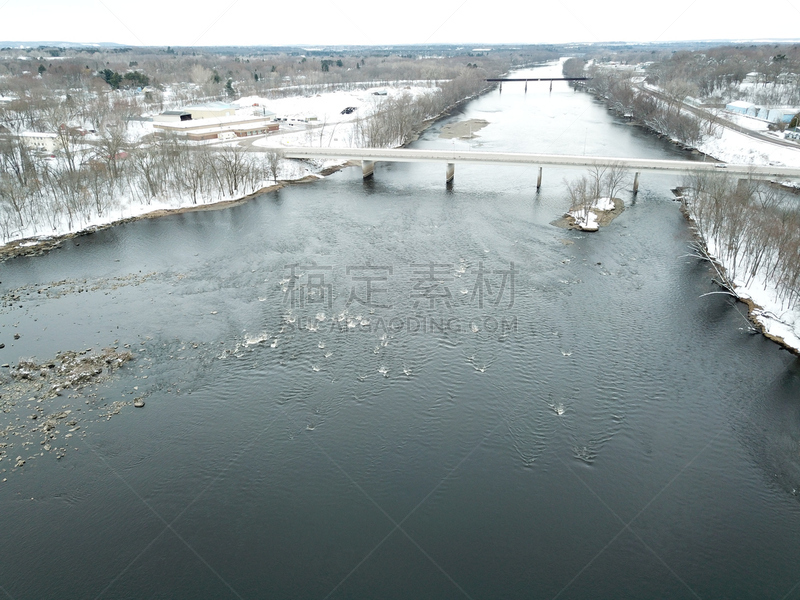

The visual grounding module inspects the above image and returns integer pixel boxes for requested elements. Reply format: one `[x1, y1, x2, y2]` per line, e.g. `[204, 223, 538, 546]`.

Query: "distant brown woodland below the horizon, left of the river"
[0, 48, 536, 109]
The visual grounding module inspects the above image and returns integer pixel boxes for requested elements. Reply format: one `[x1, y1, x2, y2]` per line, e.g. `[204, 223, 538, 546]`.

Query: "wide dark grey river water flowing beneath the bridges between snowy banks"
[0, 65, 800, 600]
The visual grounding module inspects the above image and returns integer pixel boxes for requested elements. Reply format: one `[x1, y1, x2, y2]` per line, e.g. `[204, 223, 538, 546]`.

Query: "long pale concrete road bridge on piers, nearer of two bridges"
[282, 148, 800, 193]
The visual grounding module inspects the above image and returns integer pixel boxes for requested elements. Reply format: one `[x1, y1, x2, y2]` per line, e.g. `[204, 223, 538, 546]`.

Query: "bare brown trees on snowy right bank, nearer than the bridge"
[684, 173, 800, 308]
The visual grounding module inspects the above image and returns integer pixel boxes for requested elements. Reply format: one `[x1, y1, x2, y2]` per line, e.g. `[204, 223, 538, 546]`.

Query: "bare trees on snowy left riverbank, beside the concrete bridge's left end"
[0, 137, 278, 242]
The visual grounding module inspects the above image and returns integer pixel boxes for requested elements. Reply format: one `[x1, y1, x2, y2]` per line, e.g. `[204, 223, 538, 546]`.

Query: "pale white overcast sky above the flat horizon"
[0, 0, 800, 46]
